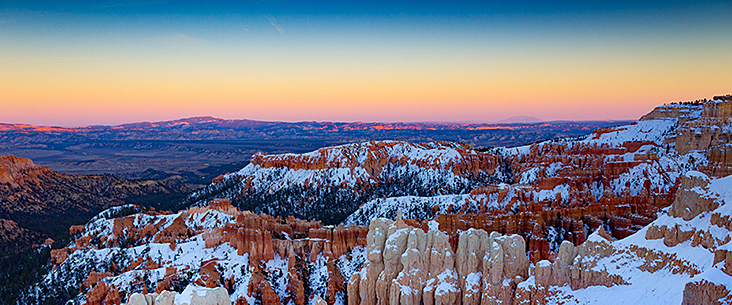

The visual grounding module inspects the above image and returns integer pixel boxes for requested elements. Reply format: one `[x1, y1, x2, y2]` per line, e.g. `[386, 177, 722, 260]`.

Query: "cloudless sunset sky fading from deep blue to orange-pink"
[0, 0, 732, 126]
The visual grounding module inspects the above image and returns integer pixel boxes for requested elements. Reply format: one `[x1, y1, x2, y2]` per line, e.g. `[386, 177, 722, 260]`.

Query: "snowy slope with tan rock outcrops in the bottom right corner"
[526, 171, 732, 304]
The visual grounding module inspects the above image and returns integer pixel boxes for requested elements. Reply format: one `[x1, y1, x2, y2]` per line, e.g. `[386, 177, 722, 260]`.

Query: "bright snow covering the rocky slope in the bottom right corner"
[527, 172, 732, 305]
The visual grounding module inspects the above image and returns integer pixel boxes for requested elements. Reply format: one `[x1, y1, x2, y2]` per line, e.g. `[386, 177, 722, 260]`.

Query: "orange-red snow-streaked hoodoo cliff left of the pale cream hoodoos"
[32, 200, 367, 305]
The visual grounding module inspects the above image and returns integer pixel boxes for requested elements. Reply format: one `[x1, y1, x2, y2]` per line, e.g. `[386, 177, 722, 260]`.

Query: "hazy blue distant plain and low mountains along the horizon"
[0, 117, 629, 188]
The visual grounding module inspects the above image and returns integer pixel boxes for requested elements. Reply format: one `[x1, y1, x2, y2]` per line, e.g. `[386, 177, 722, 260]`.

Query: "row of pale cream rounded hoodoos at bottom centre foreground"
[348, 218, 529, 305]
